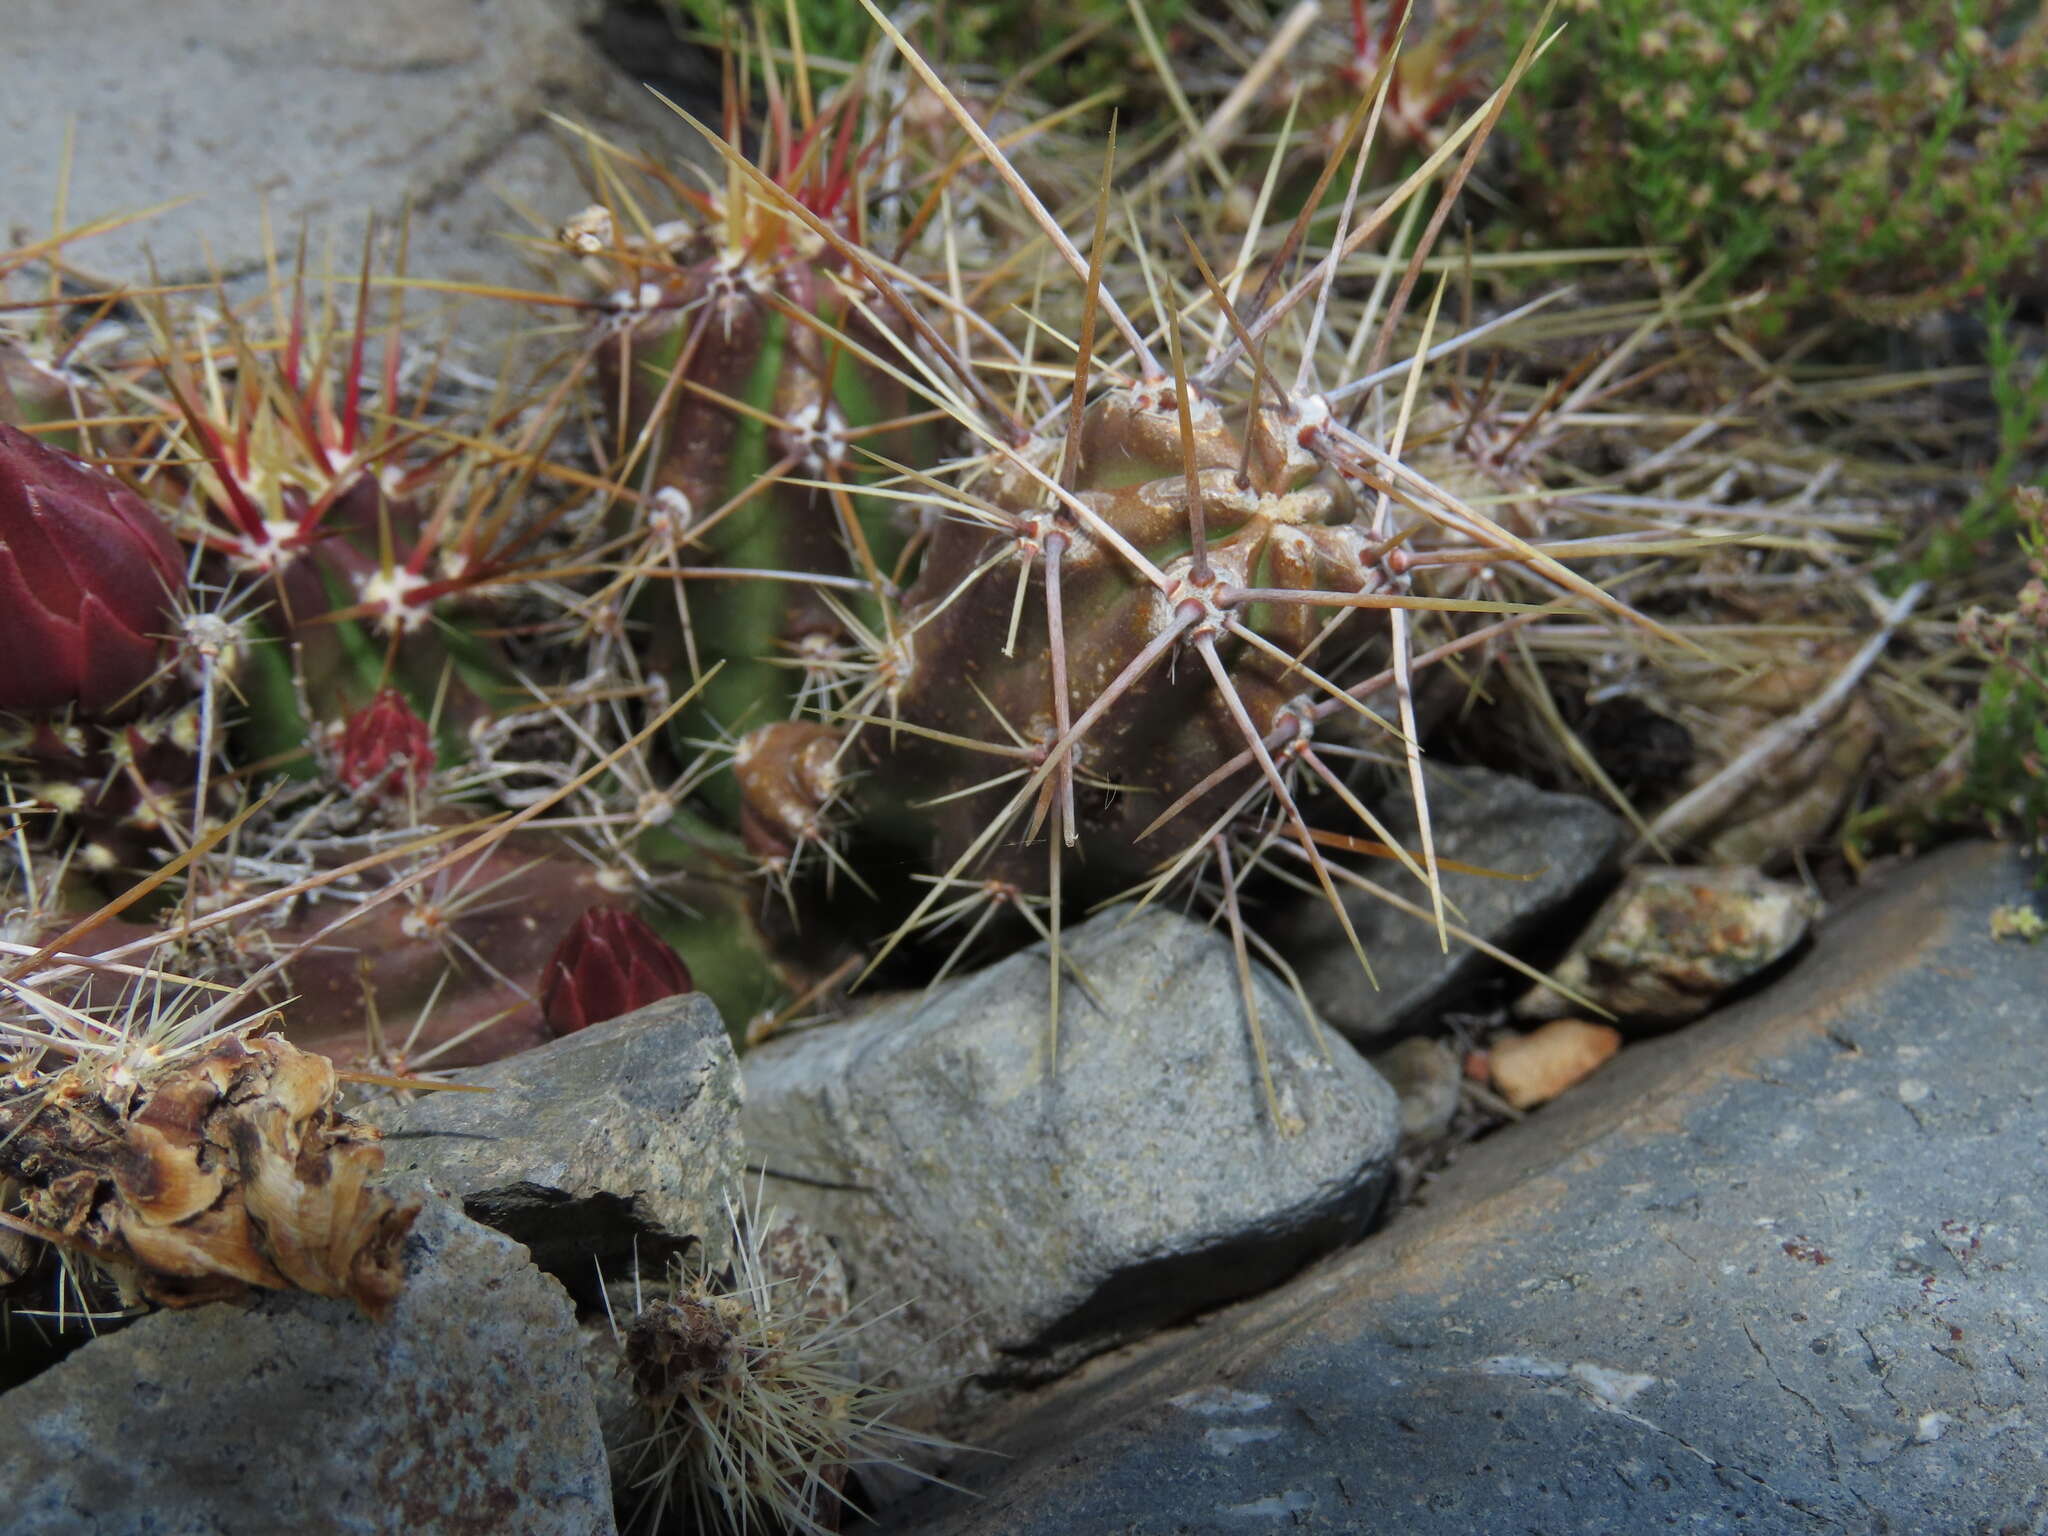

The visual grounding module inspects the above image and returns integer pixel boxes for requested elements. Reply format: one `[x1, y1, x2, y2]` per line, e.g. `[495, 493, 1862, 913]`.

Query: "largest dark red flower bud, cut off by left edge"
[0, 424, 184, 715]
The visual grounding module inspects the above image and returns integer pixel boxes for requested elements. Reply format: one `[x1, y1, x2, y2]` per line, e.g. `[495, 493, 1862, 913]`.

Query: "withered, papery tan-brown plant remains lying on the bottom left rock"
[0, 1036, 420, 1317]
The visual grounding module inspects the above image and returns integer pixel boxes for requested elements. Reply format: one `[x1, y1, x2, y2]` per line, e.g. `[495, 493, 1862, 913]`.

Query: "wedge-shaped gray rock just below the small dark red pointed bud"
[373, 993, 741, 1278]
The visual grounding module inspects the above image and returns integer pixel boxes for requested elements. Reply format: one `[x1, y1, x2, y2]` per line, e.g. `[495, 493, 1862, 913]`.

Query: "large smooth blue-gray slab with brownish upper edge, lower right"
[891, 846, 2048, 1536]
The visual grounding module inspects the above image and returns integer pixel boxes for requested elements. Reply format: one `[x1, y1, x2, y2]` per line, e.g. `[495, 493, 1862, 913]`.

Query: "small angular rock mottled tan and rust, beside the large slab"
[1516, 864, 1821, 1028]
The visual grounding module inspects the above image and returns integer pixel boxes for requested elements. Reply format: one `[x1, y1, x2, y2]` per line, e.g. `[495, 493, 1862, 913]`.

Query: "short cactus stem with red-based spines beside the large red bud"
[133, 252, 561, 794]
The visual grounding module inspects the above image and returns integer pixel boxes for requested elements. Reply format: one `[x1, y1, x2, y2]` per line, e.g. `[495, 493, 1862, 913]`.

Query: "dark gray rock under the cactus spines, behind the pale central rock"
[1286, 768, 1628, 1049]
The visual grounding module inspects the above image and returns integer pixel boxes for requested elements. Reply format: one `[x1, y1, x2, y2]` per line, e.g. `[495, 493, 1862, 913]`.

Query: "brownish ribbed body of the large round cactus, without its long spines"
[858, 383, 1374, 889]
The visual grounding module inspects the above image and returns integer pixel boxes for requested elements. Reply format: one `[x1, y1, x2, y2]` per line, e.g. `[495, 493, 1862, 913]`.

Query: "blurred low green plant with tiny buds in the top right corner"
[1503, 0, 2048, 319]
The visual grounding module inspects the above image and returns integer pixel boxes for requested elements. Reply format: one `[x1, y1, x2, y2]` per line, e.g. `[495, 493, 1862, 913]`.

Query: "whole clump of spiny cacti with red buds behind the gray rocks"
[0, 8, 1998, 1368]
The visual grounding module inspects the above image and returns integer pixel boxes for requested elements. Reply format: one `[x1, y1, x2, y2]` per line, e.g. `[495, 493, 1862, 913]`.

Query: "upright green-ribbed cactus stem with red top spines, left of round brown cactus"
[561, 75, 913, 765]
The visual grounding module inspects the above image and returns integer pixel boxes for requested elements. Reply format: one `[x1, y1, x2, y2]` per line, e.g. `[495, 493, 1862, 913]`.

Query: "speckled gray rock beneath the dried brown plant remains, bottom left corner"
[0, 1200, 614, 1536]
